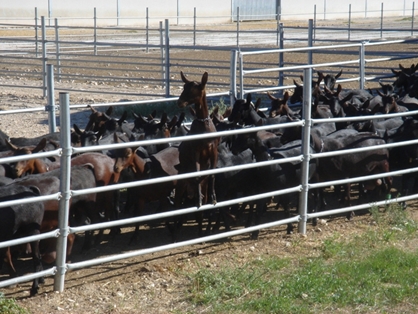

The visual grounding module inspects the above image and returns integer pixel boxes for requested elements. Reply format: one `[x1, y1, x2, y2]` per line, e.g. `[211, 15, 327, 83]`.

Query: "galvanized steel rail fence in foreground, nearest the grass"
[0, 33, 418, 291]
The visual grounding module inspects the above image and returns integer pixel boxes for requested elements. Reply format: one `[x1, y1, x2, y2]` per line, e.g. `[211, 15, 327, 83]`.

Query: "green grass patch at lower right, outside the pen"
[190, 205, 418, 313]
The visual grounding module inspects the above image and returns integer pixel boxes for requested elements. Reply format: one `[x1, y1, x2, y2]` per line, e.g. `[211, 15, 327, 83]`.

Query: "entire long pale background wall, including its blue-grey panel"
[0, 0, 415, 26]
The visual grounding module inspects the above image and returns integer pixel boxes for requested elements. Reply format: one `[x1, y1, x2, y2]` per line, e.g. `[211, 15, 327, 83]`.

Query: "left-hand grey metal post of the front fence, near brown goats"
[54, 92, 72, 292]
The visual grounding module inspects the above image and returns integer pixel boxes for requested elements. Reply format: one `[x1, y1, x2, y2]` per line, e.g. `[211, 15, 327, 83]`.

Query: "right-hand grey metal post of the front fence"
[298, 68, 312, 234]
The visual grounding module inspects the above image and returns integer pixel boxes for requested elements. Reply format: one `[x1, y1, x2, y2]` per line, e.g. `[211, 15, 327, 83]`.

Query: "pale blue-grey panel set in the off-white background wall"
[232, 0, 281, 22]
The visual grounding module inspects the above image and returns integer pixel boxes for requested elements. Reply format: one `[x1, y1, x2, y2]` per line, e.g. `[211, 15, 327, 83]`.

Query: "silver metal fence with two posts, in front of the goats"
[0, 39, 418, 291]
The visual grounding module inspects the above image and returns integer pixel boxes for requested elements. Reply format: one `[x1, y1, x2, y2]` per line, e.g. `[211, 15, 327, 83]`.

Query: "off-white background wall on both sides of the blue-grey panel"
[0, 0, 414, 26]
